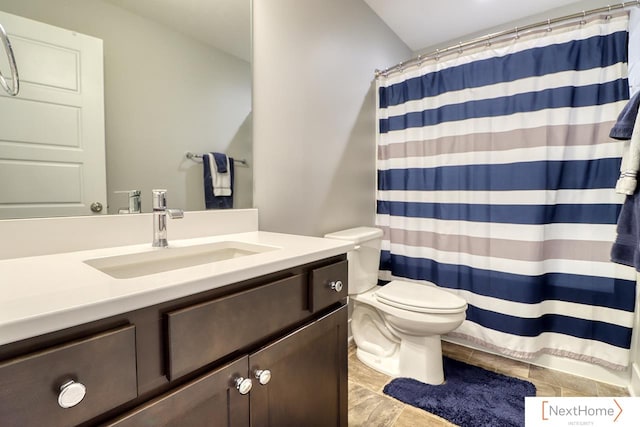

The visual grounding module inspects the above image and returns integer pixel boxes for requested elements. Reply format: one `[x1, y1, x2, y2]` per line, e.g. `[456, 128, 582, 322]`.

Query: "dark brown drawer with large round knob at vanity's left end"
[0, 326, 138, 426]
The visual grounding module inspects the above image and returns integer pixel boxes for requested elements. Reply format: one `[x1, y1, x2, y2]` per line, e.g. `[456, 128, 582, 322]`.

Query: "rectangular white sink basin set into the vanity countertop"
[84, 241, 280, 279]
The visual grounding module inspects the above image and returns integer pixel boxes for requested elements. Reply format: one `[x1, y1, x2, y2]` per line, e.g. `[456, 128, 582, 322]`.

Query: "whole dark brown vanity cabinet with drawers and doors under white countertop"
[0, 255, 347, 427]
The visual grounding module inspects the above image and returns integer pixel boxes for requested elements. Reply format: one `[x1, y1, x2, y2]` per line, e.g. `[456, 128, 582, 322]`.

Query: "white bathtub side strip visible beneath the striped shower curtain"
[443, 336, 640, 393]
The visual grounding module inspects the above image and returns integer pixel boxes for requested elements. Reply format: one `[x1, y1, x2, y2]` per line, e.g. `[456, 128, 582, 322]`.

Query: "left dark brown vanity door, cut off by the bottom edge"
[106, 356, 249, 427]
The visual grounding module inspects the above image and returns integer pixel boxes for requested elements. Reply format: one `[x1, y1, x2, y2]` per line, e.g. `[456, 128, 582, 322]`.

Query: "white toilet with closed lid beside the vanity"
[325, 227, 467, 384]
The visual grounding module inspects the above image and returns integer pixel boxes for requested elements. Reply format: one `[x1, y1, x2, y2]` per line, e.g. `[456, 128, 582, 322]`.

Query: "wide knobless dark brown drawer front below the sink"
[167, 274, 308, 380]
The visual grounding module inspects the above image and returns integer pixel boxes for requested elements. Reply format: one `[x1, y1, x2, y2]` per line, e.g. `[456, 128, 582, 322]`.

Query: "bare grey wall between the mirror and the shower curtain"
[253, 0, 411, 236]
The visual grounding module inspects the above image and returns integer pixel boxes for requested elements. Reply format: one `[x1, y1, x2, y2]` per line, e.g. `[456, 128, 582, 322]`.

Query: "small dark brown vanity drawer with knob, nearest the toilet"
[309, 260, 349, 312]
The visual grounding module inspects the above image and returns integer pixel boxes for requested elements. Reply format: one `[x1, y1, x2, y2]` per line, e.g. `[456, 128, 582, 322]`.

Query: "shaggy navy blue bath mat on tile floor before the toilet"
[384, 357, 536, 427]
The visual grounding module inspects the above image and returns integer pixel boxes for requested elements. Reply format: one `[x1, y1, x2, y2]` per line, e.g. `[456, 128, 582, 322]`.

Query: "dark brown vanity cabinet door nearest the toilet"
[249, 306, 347, 427]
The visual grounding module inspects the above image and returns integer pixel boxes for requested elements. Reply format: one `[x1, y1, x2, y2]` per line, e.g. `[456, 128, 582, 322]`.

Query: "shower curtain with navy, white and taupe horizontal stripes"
[376, 14, 635, 369]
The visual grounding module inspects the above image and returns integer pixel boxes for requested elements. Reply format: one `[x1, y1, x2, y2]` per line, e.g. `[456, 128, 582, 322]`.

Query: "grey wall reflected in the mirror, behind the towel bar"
[0, 0, 253, 213]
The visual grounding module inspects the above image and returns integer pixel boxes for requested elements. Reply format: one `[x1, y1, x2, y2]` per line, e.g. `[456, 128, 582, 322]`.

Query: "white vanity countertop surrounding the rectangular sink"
[0, 231, 353, 345]
